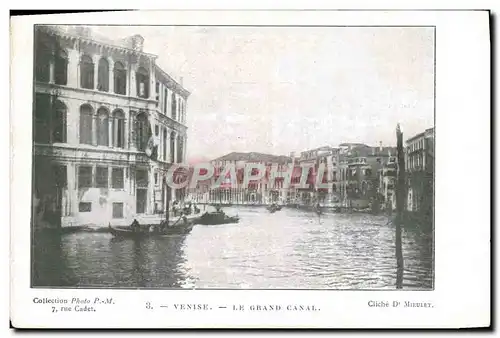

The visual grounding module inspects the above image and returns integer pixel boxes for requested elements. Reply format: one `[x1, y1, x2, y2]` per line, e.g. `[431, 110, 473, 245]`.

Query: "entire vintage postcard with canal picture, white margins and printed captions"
[11, 11, 490, 328]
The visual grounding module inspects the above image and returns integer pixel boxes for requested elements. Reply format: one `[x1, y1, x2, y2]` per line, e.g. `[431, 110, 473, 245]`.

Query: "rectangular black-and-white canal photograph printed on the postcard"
[32, 25, 435, 290]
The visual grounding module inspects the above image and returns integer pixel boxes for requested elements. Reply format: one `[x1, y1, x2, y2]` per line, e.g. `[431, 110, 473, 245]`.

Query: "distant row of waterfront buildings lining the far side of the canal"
[189, 128, 434, 215]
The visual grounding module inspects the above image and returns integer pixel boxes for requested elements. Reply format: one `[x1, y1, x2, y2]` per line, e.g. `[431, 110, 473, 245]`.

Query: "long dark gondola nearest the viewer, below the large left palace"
[108, 217, 194, 239]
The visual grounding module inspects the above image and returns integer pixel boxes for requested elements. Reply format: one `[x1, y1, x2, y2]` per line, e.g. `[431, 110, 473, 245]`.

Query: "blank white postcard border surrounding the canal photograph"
[11, 11, 491, 328]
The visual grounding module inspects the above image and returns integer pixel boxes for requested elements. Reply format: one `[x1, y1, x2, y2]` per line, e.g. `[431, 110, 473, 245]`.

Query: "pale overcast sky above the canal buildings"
[94, 27, 434, 159]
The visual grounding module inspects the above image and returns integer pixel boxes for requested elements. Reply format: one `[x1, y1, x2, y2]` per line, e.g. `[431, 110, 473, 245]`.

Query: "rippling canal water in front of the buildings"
[32, 207, 434, 290]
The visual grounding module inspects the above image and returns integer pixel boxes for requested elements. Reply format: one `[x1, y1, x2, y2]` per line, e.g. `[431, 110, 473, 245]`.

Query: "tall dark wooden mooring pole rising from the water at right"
[395, 123, 406, 289]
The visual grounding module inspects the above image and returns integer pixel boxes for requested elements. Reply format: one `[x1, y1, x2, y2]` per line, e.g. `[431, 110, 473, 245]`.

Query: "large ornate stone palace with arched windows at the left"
[33, 26, 190, 227]
